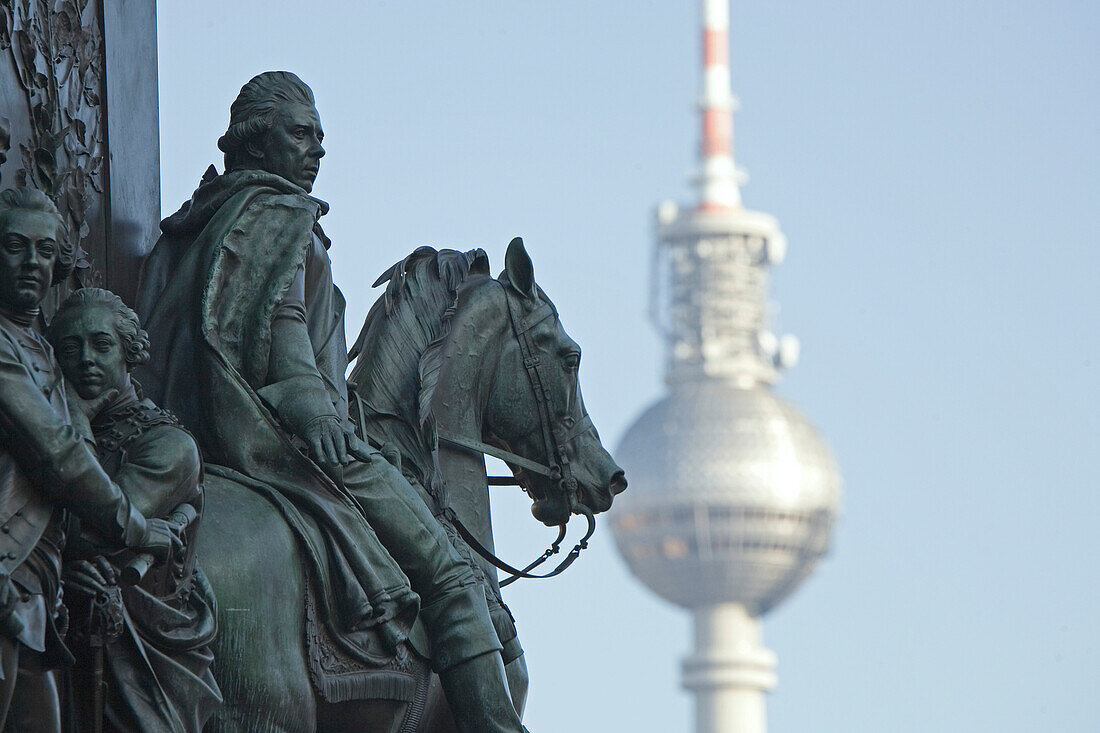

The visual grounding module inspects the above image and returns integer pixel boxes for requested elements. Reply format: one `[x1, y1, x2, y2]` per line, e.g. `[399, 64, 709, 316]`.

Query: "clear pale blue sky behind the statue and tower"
[160, 0, 1100, 733]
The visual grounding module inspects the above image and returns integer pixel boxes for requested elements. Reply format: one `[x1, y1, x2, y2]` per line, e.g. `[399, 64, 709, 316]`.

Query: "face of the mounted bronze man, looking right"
[259, 102, 325, 192]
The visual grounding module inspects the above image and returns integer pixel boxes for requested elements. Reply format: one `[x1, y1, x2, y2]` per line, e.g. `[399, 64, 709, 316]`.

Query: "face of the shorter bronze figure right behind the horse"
[53, 307, 130, 400]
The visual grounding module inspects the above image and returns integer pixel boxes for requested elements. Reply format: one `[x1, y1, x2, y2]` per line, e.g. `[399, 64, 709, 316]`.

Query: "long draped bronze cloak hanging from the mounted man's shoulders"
[138, 168, 419, 663]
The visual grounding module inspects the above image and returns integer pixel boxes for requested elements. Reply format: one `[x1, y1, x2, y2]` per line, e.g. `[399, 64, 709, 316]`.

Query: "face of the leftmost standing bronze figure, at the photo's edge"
[0, 209, 61, 311]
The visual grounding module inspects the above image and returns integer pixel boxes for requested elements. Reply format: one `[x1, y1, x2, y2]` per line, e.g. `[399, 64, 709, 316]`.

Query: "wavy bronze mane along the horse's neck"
[348, 247, 488, 486]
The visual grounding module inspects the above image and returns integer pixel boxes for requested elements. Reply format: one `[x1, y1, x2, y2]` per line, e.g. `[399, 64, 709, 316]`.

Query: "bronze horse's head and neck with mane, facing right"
[350, 238, 626, 530]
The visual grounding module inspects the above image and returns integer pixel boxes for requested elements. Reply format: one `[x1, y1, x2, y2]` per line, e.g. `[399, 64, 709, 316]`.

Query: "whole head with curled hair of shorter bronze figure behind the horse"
[46, 287, 149, 400]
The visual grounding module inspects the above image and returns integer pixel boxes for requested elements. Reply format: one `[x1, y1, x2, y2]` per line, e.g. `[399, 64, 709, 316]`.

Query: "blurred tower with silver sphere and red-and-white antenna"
[613, 0, 840, 733]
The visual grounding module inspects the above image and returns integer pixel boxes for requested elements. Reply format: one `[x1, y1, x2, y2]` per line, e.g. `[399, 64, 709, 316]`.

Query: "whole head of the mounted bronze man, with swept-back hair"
[218, 72, 325, 192]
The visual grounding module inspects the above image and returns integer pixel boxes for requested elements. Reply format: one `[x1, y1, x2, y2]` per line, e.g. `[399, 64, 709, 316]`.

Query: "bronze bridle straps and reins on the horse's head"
[437, 285, 596, 588]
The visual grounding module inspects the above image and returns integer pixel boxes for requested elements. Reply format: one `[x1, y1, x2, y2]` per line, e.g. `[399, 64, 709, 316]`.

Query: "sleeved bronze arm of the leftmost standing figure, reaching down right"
[0, 330, 146, 546]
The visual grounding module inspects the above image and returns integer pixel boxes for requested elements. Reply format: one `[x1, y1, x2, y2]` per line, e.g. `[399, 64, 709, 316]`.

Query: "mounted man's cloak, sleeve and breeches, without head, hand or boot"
[140, 171, 501, 669]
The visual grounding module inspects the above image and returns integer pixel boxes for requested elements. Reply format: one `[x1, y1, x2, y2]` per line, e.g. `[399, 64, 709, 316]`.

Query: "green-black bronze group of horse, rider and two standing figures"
[0, 72, 626, 733]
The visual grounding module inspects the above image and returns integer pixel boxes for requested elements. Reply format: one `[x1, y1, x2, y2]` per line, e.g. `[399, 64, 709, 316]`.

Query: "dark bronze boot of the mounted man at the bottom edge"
[439, 652, 527, 733]
